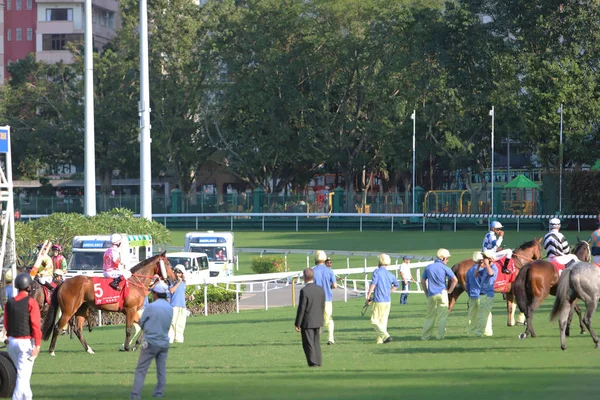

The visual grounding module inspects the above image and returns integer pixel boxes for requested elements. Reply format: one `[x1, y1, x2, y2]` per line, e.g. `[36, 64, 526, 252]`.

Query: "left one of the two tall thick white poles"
[83, 0, 96, 216]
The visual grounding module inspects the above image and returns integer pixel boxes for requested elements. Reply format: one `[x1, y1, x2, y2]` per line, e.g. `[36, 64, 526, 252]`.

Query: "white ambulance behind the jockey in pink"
[66, 233, 152, 278]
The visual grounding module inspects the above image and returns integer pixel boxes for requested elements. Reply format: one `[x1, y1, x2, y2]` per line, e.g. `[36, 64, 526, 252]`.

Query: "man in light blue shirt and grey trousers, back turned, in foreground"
[129, 282, 173, 399]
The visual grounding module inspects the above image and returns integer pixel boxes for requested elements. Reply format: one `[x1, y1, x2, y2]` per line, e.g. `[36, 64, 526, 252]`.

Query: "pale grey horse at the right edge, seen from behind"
[550, 262, 600, 350]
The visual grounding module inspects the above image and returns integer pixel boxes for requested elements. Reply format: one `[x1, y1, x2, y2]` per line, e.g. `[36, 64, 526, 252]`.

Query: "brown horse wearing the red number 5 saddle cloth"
[42, 252, 175, 355]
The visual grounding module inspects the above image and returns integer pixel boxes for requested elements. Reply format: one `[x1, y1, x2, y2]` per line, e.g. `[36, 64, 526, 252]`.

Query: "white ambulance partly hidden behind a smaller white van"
[184, 231, 235, 276]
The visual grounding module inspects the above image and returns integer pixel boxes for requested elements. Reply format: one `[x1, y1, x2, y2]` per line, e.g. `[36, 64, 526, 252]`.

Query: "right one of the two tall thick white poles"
[139, 0, 152, 220]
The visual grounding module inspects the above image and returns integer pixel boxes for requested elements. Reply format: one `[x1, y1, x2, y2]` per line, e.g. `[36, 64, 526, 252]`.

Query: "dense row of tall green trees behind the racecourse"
[0, 0, 600, 192]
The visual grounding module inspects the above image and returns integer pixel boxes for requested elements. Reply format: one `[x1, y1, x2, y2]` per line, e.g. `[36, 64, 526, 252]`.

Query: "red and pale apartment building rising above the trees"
[0, 0, 121, 85]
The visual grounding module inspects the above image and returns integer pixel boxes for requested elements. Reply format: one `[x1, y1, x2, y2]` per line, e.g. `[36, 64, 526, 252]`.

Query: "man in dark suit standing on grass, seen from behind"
[294, 268, 325, 367]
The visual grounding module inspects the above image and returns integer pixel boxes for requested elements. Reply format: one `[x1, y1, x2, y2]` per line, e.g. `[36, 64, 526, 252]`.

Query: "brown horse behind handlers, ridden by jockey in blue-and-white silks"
[448, 238, 542, 326]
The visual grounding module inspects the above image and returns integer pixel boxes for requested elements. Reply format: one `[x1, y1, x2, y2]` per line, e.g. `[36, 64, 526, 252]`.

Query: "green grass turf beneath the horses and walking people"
[32, 232, 600, 400]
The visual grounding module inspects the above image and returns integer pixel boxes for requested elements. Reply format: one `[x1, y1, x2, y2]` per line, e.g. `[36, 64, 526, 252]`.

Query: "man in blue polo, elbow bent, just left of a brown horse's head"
[421, 249, 458, 340]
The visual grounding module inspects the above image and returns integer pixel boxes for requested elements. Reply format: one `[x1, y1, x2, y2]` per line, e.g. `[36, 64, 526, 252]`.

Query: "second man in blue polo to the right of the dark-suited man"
[367, 254, 399, 344]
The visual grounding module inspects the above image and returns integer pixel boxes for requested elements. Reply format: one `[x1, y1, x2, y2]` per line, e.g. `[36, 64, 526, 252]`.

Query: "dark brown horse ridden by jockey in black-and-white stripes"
[513, 240, 591, 339]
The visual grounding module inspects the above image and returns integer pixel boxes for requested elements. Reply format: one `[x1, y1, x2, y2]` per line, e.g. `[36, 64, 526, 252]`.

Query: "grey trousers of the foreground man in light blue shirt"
[130, 344, 169, 399]
